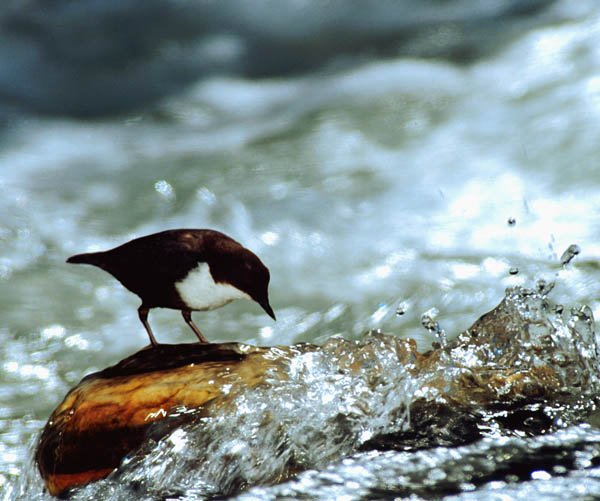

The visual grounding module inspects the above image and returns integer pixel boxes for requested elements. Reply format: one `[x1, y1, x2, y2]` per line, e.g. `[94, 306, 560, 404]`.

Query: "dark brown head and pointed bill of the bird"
[210, 244, 276, 320]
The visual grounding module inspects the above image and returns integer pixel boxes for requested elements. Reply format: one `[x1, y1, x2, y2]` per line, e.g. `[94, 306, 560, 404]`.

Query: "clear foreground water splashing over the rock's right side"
[11, 281, 600, 499]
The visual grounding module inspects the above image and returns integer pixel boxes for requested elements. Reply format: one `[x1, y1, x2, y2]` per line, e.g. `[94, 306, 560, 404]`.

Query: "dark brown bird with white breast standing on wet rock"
[67, 230, 275, 346]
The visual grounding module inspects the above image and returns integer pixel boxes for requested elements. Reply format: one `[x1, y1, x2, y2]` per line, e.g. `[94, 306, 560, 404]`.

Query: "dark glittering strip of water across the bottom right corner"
[236, 426, 600, 501]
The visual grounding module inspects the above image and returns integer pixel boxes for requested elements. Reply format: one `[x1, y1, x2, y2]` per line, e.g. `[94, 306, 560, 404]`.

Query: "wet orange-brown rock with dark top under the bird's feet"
[36, 344, 282, 495]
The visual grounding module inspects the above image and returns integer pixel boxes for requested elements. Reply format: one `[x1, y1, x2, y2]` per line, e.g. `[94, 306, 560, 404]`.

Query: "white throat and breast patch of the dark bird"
[175, 263, 252, 310]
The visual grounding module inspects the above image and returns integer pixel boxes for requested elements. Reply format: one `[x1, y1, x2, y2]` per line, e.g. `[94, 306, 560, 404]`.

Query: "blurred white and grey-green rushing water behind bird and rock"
[0, 0, 600, 488]
